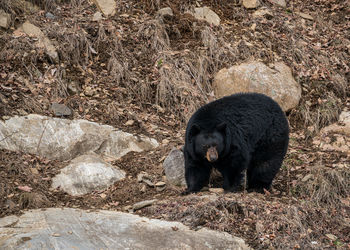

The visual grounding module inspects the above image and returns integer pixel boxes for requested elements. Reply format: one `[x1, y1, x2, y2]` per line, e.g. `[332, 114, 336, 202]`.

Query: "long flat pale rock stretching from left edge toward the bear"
[0, 114, 159, 160]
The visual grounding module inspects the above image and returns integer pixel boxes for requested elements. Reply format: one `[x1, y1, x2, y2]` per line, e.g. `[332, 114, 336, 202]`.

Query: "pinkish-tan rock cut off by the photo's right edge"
[313, 111, 350, 155]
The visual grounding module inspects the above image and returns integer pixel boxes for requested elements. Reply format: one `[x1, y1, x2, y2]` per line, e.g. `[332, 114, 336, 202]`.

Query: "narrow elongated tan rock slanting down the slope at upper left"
[18, 22, 58, 62]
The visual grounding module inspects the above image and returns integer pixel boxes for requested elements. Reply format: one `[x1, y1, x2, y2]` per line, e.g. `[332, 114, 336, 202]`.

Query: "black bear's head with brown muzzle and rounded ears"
[188, 123, 229, 163]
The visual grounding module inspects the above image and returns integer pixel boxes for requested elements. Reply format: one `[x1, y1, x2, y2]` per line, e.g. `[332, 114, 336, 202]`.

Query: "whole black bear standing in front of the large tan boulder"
[184, 93, 289, 194]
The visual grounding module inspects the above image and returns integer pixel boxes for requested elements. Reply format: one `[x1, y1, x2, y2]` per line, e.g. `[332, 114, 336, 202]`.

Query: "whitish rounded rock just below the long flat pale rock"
[52, 155, 125, 195]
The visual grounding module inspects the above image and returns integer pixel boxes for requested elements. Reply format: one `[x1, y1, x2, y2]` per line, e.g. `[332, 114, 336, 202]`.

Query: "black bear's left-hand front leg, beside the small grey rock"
[182, 160, 211, 194]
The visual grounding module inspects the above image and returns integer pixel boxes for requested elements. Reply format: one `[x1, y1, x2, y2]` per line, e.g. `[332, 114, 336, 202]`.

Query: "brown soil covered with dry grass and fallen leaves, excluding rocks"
[0, 0, 350, 249]
